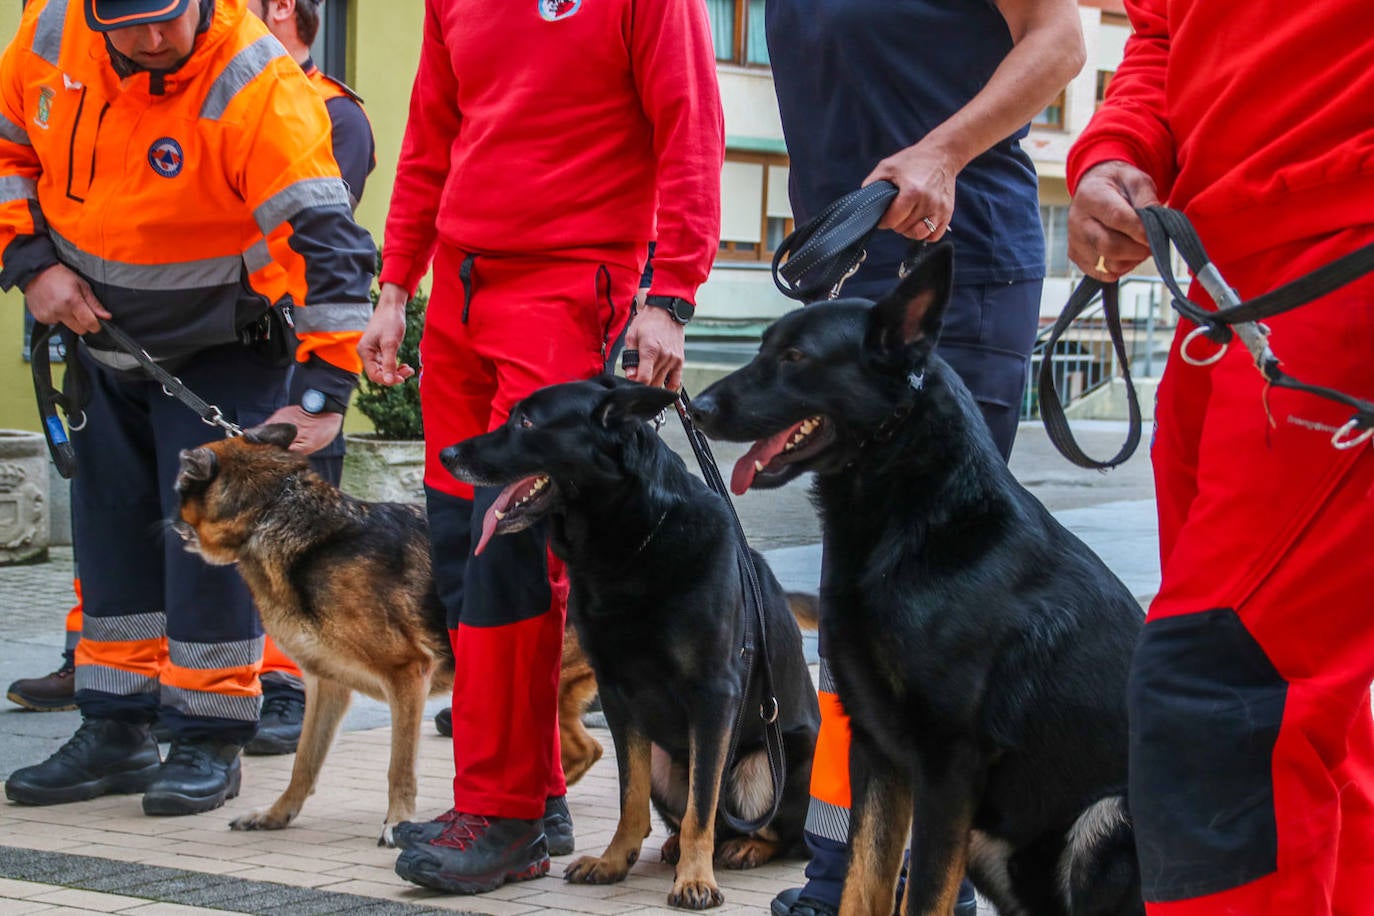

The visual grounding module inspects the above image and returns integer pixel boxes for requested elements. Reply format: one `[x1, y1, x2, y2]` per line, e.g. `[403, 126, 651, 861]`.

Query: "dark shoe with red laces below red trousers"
[396, 813, 548, 894]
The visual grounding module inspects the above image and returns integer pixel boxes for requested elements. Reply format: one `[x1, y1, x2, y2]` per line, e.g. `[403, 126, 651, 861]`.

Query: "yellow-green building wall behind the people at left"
[0, 0, 425, 430]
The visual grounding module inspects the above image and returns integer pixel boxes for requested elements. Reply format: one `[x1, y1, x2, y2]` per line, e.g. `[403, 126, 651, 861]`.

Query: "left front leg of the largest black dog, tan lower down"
[840, 733, 912, 916]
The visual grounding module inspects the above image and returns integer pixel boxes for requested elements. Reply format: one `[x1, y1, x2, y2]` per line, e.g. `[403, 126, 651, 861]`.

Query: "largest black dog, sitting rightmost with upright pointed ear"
[681, 244, 1145, 916]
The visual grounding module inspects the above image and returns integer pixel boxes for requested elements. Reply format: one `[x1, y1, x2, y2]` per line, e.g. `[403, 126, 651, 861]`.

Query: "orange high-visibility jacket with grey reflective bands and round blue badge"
[0, 0, 375, 379]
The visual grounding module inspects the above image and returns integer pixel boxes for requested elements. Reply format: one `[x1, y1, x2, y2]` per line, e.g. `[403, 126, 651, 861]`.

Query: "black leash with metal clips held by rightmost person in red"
[1039, 206, 1374, 470]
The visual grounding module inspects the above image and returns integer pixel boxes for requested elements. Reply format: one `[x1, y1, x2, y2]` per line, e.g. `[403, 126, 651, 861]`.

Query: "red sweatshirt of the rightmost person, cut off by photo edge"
[1068, 0, 1374, 264]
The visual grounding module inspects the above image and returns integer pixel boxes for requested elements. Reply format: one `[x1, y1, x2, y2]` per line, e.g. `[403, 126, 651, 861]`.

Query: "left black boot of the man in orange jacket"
[4, 718, 161, 805]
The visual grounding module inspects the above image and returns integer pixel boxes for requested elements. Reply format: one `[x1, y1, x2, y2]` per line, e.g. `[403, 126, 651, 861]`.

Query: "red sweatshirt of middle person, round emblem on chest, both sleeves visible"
[381, 0, 724, 298]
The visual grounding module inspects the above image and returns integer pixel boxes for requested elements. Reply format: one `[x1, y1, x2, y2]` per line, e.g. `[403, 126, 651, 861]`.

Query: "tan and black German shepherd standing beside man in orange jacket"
[173, 423, 602, 846]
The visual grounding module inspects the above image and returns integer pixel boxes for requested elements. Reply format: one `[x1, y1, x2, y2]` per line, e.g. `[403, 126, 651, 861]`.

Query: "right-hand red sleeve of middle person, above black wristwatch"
[631, 0, 725, 299]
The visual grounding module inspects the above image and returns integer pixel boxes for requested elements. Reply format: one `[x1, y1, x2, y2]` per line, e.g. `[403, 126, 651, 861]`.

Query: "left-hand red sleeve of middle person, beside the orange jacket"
[378, 0, 463, 295]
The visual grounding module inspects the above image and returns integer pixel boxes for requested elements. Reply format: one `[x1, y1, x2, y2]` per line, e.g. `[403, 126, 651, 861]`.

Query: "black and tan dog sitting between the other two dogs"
[440, 376, 820, 909]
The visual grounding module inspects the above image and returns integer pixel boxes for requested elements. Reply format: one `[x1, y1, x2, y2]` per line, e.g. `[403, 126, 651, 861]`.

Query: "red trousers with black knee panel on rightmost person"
[1129, 227, 1374, 916]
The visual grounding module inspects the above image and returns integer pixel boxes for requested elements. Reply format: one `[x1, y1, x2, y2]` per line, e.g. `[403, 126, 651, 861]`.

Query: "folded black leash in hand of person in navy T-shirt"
[772, 181, 897, 302]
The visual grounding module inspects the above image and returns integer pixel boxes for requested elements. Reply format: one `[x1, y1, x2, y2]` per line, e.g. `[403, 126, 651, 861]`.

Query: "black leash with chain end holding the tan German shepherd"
[30, 319, 243, 479]
